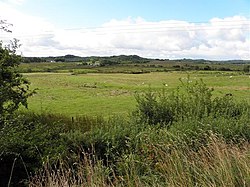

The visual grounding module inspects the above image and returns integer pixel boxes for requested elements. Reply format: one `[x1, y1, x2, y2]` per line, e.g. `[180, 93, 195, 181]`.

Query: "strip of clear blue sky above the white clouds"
[13, 0, 250, 28]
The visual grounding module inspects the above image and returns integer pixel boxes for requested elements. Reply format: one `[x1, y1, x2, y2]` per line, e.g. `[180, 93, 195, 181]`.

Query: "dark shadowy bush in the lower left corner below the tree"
[0, 113, 103, 186]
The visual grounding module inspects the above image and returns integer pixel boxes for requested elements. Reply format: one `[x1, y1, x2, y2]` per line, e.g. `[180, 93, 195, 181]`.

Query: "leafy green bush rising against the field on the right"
[135, 78, 250, 126]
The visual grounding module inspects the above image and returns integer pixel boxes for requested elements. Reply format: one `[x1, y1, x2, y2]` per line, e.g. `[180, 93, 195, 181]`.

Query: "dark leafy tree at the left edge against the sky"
[0, 20, 34, 124]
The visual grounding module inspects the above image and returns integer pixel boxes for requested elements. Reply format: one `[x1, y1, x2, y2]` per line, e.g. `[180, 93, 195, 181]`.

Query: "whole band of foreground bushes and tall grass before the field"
[0, 79, 250, 186]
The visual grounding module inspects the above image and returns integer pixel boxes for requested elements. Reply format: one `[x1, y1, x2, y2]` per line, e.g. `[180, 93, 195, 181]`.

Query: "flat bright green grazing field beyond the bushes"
[24, 71, 250, 116]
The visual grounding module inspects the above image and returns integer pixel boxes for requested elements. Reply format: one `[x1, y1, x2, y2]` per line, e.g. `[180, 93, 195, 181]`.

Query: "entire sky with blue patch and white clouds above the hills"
[0, 0, 250, 60]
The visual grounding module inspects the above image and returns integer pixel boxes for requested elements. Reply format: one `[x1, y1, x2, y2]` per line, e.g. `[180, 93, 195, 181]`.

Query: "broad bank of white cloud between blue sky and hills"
[0, 1, 250, 59]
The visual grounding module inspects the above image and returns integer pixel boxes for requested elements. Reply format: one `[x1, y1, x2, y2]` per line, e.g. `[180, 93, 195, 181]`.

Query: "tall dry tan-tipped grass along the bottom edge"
[29, 134, 250, 187]
